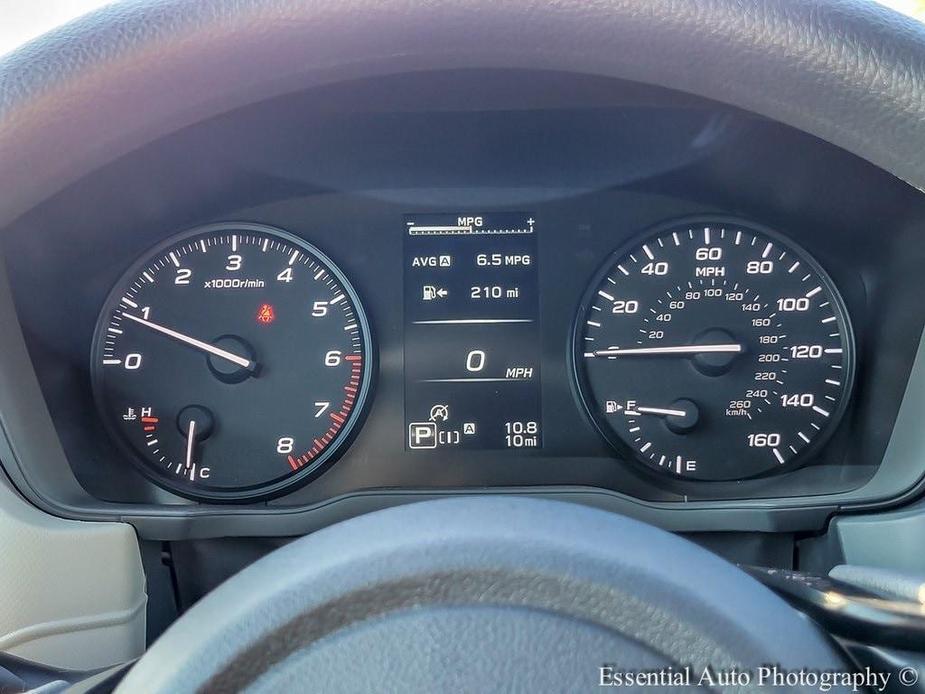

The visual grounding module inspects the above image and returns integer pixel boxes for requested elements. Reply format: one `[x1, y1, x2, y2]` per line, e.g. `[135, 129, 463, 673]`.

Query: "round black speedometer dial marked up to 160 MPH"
[574, 221, 853, 480]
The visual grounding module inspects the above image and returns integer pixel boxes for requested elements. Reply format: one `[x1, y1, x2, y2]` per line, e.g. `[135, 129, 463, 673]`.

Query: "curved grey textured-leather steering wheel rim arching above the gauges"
[0, 0, 925, 239]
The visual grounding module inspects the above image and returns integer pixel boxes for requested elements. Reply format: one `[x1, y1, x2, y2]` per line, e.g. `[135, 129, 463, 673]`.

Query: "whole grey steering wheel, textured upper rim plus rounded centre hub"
[0, 0, 925, 692]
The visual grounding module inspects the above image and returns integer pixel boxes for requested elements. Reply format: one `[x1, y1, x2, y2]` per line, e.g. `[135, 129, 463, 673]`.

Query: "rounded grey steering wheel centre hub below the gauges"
[113, 497, 845, 692]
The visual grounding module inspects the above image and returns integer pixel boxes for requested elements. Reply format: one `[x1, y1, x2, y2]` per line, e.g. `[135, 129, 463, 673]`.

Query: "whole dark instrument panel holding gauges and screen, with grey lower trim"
[3, 71, 925, 538]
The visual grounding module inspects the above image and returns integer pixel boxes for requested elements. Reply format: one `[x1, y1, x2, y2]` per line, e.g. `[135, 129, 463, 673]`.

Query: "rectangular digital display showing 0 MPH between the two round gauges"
[404, 212, 543, 451]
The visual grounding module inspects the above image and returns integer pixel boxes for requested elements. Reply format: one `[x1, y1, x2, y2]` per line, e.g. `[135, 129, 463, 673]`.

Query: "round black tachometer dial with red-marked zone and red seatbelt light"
[92, 224, 371, 500]
